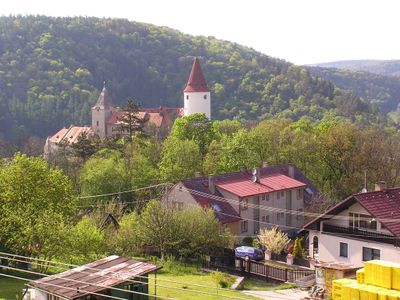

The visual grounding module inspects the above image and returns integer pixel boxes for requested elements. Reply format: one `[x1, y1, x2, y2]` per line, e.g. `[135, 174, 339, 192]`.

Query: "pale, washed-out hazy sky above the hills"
[0, 0, 400, 64]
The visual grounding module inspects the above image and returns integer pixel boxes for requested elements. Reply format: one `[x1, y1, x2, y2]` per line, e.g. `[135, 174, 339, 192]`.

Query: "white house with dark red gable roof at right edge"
[304, 182, 400, 266]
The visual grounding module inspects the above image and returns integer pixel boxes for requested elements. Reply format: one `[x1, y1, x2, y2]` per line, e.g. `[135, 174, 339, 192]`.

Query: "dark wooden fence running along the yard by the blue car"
[204, 257, 315, 282]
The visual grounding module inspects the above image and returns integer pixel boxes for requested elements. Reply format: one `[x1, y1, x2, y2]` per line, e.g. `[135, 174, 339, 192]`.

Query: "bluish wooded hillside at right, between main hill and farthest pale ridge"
[307, 67, 400, 114]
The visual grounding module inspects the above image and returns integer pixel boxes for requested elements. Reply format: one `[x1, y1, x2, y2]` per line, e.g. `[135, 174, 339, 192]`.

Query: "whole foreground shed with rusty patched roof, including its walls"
[24, 255, 162, 300]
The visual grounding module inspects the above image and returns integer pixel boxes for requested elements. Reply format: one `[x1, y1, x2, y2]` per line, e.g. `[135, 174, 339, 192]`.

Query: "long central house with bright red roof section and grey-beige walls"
[162, 165, 319, 239]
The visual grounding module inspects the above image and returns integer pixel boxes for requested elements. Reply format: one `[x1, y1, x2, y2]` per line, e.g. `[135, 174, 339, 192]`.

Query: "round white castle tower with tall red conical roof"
[183, 57, 211, 119]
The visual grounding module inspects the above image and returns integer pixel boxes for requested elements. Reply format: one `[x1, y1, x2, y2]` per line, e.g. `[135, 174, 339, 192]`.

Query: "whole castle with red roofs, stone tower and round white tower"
[44, 57, 211, 157]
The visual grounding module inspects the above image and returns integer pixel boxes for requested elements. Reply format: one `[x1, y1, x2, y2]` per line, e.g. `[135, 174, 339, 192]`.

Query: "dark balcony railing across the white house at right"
[322, 224, 400, 247]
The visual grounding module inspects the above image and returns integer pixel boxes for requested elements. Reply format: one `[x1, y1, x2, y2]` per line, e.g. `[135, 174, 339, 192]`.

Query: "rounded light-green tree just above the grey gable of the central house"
[160, 137, 202, 182]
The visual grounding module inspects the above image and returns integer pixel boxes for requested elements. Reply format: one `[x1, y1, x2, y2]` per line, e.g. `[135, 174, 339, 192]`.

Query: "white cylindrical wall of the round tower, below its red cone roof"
[183, 92, 211, 119]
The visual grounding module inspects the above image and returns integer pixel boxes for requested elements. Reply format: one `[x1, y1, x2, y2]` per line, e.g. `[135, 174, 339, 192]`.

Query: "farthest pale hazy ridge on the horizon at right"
[312, 60, 400, 76]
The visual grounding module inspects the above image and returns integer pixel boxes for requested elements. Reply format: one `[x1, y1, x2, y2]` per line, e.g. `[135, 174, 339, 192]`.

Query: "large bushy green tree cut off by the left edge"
[0, 154, 76, 259]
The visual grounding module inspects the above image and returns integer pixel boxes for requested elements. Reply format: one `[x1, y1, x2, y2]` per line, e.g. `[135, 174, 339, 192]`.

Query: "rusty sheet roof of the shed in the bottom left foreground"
[27, 255, 162, 299]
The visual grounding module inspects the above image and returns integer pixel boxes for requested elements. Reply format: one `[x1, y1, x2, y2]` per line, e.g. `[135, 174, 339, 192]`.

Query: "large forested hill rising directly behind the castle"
[0, 16, 377, 139]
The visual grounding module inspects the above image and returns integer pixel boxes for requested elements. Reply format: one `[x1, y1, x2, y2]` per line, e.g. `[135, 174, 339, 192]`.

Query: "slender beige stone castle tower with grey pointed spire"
[92, 82, 112, 139]
